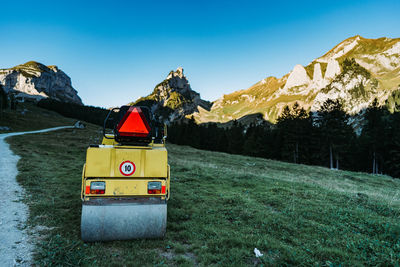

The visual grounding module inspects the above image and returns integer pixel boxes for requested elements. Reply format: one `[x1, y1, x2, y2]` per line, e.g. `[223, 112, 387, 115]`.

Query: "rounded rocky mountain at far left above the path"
[0, 61, 82, 105]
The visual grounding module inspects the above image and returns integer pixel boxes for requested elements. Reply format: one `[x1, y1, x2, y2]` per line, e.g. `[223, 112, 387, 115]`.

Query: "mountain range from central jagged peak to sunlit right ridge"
[132, 36, 400, 123]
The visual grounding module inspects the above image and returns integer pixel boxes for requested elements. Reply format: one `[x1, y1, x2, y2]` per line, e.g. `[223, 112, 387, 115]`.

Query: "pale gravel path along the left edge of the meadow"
[0, 126, 74, 267]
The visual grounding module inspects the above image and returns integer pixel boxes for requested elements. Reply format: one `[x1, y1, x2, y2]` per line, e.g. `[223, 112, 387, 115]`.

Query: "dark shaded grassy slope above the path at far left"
[0, 102, 77, 133]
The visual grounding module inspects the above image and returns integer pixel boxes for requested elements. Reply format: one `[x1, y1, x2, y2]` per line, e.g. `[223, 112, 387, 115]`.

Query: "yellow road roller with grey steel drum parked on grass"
[81, 106, 170, 242]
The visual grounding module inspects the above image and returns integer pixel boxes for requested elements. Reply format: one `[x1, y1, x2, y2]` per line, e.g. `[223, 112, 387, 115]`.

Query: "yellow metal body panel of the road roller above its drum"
[81, 135, 170, 201]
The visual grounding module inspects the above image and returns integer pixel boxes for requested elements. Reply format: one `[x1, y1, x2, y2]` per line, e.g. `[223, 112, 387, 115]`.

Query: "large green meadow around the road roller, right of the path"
[8, 129, 400, 266]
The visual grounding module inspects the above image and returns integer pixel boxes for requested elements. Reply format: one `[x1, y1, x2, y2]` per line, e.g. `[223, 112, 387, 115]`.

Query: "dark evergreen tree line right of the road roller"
[168, 99, 400, 177]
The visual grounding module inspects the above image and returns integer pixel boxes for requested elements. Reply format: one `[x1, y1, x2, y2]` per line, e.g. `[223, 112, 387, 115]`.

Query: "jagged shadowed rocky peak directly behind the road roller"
[131, 67, 211, 124]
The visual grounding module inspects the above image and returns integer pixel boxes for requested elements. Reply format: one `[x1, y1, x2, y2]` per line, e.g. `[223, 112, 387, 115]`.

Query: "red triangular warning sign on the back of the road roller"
[117, 107, 151, 137]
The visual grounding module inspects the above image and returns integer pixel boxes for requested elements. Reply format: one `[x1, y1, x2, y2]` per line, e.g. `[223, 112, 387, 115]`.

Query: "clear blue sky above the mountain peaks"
[0, 0, 400, 107]
